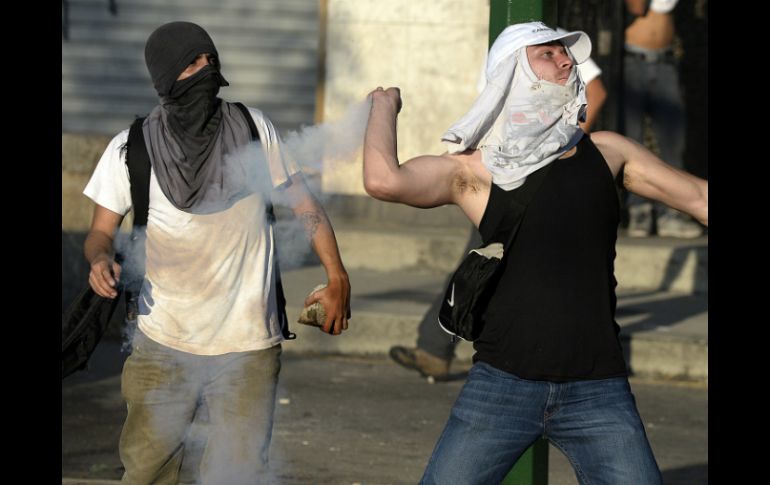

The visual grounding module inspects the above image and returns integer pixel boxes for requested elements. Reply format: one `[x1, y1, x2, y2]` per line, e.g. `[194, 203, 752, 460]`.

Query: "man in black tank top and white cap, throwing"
[364, 22, 708, 485]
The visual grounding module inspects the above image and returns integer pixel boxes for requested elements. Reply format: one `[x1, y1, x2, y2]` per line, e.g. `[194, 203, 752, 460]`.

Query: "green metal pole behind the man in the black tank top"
[489, 0, 557, 485]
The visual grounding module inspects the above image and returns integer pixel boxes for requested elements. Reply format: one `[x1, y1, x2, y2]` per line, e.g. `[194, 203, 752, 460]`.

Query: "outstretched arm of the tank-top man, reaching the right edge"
[591, 131, 708, 226]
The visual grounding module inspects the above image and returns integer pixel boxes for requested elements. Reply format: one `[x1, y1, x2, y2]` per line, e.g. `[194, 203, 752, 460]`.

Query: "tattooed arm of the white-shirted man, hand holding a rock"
[282, 173, 350, 335]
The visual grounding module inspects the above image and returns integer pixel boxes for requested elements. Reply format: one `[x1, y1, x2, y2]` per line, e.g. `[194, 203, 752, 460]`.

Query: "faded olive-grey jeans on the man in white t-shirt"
[120, 330, 281, 485]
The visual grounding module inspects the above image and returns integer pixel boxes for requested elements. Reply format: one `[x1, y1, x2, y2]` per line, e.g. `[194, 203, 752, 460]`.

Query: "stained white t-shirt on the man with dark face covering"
[83, 108, 299, 355]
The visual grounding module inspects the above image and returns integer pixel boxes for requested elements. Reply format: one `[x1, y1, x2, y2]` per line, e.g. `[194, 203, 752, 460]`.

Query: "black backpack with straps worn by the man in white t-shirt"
[62, 103, 296, 379]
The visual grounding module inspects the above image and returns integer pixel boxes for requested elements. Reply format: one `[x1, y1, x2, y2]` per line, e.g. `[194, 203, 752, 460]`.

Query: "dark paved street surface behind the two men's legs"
[62, 341, 708, 485]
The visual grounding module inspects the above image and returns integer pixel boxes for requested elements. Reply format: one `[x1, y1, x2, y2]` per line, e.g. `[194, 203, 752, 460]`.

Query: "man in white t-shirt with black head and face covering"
[84, 22, 350, 484]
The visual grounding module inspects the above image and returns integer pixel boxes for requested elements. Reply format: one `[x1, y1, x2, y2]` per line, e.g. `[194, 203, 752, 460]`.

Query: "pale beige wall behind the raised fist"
[321, 0, 489, 195]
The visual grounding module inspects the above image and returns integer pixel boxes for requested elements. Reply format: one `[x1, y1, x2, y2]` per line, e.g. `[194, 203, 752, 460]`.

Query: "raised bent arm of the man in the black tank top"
[364, 88, 461, 208]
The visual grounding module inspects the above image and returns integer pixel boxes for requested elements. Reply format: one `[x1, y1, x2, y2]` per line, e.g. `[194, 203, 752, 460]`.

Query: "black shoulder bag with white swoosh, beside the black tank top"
[438, 162, 553, 342]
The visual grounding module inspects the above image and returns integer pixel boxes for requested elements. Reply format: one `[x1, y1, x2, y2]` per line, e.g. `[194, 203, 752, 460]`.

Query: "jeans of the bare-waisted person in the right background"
[621, 47, 686, 209]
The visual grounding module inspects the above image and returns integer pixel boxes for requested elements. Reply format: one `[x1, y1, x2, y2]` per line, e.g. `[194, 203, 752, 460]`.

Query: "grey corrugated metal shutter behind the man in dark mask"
[62, 0, 319, 135]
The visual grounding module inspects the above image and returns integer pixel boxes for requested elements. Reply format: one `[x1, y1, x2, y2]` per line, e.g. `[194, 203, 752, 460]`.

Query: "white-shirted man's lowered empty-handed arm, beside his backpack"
[83, 204, 123, 298]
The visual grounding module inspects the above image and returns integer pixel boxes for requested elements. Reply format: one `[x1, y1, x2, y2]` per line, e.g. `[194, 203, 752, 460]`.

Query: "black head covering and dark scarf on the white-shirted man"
[143, 22, 251, 214]
